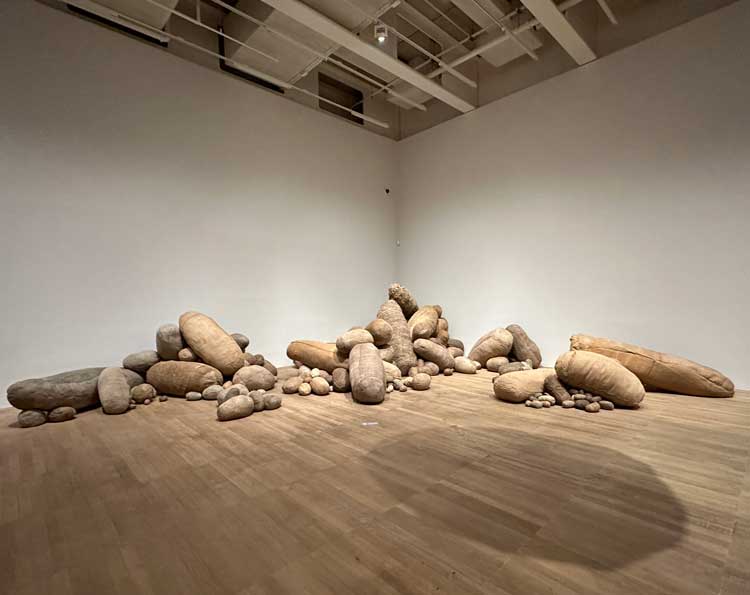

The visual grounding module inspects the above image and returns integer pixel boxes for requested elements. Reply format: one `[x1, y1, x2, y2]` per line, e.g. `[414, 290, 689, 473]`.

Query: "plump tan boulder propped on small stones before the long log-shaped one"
[560, 351, 646, 407]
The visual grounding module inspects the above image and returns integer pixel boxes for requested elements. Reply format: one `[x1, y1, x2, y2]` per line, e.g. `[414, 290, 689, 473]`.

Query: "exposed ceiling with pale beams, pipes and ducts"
[43, 0, 740, 138]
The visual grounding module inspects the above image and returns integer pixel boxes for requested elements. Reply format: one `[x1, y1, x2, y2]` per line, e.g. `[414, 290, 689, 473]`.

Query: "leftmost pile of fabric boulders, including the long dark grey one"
[8, 312, 281, 427]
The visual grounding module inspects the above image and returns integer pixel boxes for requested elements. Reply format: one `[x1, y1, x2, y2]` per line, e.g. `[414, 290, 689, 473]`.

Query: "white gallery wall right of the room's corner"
[398, 0, 750, 388]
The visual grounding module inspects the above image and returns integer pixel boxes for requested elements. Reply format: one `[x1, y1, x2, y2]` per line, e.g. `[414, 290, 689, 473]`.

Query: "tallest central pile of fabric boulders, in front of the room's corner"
[282, 283, 464, 404]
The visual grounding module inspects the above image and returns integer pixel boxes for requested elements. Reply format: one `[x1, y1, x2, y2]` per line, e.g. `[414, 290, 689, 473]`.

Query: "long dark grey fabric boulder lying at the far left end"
[7, 368, 104, 411]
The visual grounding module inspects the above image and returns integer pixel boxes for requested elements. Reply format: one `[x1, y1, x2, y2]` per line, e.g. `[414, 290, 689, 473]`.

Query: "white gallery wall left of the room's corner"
[0, 0, 396, 406]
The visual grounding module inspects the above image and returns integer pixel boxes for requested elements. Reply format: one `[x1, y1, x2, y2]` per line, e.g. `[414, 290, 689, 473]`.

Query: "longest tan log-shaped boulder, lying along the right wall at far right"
[570, 335, 734, 397]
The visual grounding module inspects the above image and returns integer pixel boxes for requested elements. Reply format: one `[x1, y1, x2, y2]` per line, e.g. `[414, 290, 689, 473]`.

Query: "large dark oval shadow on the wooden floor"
[366, 426, 686, 569]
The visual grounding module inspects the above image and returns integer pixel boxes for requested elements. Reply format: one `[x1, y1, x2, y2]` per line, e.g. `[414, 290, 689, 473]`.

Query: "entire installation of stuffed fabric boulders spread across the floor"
[2, 283, 734, 427]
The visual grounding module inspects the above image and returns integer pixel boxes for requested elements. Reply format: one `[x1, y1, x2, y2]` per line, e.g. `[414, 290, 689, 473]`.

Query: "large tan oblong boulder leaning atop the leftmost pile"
[180, 312, 245, 376]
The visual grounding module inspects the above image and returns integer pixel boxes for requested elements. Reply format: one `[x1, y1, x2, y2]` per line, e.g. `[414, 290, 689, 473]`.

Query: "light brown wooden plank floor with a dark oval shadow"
[0, 372, 750, 595]
